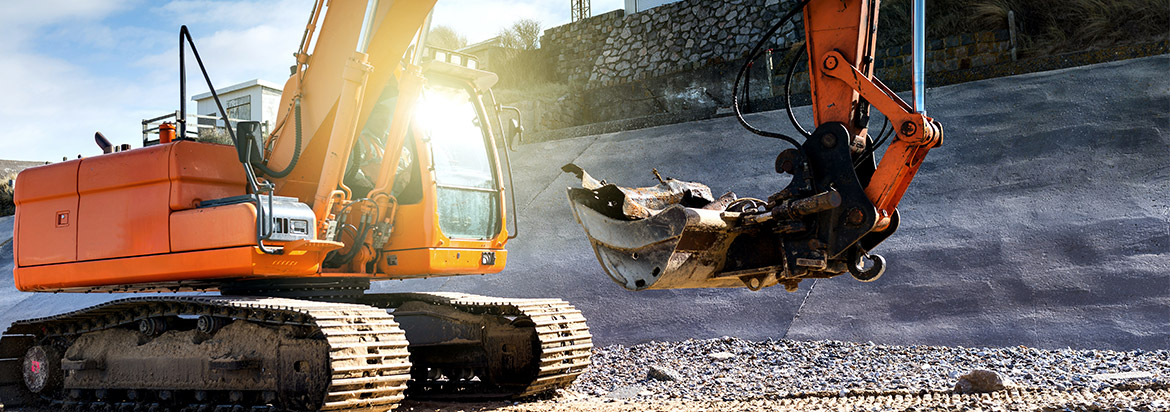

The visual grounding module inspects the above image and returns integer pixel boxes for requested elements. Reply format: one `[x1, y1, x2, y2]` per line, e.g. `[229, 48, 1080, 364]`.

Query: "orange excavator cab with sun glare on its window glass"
[377, 52, 510, 279]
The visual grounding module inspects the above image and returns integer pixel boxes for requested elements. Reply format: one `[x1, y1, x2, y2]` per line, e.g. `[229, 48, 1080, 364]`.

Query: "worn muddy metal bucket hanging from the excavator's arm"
[562, 164, 783, 290]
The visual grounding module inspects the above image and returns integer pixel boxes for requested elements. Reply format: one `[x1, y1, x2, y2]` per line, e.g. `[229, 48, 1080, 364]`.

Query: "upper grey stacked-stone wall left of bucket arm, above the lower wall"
[541, 0, 804, 89]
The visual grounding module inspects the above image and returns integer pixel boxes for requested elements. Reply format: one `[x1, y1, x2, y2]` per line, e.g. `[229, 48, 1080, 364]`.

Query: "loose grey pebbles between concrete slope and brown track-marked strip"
[570, 337, 1170, 400]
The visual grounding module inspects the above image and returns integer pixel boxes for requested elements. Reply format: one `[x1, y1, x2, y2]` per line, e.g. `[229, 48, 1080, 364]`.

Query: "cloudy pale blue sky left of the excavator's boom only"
[0, 0, 311, 160]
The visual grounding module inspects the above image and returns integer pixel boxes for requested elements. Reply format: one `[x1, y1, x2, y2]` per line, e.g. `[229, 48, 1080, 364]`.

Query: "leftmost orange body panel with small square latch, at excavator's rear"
[13, 160, 81, 266]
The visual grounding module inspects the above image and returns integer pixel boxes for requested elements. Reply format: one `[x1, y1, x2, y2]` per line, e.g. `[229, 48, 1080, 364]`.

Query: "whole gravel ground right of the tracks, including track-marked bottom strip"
[399, 337, 1170, 412]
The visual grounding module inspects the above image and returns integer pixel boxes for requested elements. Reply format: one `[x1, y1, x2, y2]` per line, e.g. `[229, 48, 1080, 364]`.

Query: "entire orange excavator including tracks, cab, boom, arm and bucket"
[0, 0, 942, 411]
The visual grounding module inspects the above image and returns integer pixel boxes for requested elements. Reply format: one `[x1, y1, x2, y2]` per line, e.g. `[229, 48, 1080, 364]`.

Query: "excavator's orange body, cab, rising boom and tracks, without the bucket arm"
[0, 0, 592, 411]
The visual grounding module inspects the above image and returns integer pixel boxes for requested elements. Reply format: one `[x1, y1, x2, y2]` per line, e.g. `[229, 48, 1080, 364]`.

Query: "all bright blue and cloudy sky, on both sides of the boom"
[0, 0, 624, 160]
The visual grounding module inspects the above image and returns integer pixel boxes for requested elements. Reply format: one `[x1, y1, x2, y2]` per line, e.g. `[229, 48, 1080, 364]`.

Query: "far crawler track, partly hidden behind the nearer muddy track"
[362, 293, 593, 399]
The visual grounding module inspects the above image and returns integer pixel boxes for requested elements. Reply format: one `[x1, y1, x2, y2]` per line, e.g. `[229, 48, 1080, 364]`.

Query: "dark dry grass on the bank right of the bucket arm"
[878, 0, 1170, 56]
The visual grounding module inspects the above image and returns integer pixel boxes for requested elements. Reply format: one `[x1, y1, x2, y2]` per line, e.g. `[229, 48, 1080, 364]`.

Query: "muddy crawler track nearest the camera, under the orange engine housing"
[0, 296, 411, 411]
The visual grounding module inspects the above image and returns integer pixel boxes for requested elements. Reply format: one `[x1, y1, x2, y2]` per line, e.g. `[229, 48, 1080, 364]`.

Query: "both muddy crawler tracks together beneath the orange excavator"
[0, 293, 593, 411]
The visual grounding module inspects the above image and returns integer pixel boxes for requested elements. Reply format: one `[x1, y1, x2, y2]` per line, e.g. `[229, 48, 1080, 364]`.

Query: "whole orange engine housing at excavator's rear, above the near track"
[15, 142, 258, 290]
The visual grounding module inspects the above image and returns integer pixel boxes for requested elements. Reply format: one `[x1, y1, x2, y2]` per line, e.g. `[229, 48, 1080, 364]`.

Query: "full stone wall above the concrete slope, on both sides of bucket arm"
[519, 0, 1011, 131]
